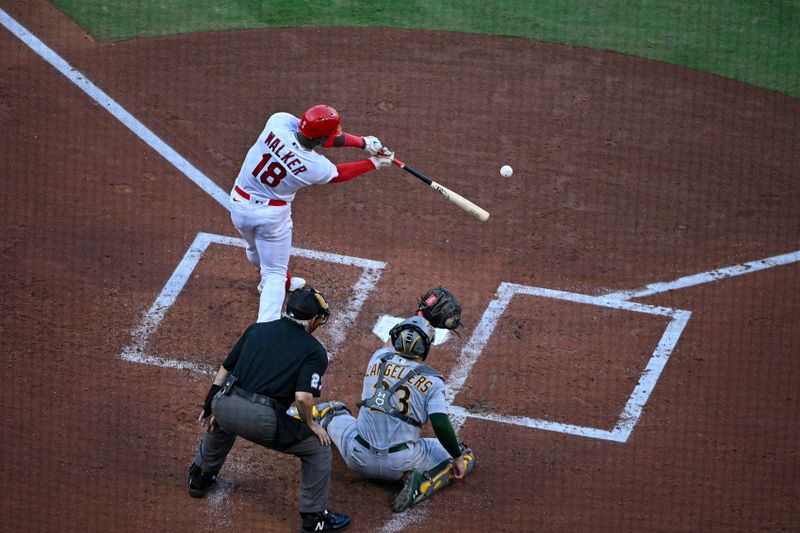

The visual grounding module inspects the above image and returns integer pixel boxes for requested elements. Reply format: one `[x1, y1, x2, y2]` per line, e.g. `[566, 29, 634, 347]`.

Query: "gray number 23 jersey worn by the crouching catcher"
[358, 347, 447, 448]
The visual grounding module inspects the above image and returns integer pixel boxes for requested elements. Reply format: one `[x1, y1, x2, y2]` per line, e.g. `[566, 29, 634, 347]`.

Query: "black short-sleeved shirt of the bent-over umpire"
[222, 318, 328, 405]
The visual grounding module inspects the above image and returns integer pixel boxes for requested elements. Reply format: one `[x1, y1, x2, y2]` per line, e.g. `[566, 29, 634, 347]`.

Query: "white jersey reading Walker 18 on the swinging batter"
[236, 113, 338, 202]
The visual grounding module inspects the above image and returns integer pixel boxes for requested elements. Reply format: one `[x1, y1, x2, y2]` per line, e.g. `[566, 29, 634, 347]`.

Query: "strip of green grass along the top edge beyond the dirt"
[53, 0, 800, 98]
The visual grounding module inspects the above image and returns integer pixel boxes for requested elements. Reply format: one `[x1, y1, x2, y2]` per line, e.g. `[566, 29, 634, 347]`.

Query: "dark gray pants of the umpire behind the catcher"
[194, 394, 331, 513]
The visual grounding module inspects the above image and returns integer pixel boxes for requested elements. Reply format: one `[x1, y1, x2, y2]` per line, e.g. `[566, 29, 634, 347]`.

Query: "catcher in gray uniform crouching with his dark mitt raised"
[290, 287, 475, 512]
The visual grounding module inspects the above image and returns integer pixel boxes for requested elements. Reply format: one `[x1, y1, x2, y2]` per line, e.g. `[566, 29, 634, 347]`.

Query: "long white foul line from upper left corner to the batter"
[0, 9, 229, 209]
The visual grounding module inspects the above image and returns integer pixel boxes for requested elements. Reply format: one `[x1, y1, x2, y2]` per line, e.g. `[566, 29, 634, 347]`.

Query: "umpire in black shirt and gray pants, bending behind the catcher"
[189, 287, 350, 531]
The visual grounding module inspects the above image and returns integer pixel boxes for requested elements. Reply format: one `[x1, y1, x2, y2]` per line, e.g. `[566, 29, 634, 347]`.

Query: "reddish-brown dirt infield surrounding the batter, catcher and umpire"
[0, 0, 800, 531]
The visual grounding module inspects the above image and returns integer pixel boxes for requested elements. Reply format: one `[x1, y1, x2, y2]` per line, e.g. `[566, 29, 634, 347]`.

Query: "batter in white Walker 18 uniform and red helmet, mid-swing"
[230, 105, 394, 322]
